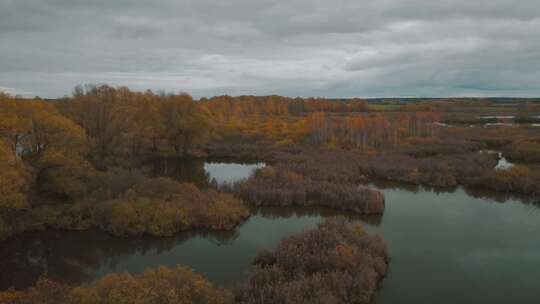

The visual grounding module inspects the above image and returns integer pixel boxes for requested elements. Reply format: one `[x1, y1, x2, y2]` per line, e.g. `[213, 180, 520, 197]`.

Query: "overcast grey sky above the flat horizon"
[0, 0, 540, 97]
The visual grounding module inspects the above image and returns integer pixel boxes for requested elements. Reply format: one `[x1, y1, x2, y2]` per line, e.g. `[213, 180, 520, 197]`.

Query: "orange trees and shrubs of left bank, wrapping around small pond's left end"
[0, 86, 248, 239]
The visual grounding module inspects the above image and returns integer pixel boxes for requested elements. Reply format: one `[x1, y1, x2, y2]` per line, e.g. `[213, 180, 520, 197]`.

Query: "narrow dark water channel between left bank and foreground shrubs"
[0, 210, 326, 289]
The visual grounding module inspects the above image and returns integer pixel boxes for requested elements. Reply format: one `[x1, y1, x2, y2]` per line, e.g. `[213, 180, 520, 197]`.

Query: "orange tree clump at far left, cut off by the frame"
[0, 92, 86, 202]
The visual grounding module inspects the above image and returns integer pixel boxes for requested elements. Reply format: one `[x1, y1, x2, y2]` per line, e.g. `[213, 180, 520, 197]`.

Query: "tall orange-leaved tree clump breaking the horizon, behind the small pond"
[60, 86, 211, 165]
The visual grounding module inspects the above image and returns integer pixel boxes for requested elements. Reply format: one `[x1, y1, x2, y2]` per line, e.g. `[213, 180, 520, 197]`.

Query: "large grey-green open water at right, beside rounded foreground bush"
[369, 184, 540, 303]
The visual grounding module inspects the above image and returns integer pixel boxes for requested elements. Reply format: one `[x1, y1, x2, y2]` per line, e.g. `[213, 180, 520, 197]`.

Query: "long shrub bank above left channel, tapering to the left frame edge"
[5, 170, 249, 238]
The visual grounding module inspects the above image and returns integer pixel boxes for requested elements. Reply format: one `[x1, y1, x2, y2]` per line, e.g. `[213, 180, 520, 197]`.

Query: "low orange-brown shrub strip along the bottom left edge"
[0, 266, 233, 304]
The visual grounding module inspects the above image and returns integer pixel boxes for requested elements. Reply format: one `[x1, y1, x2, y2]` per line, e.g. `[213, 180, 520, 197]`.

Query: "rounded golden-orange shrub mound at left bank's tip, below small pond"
[95, 178, 249, 236]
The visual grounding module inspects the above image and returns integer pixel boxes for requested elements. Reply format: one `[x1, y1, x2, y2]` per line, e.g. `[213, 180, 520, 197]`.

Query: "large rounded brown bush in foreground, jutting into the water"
[236, 218, 388, 303]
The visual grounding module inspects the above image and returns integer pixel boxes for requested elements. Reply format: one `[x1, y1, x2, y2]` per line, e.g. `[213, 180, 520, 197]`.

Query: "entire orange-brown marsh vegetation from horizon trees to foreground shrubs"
[0, 85, 540, 303]
